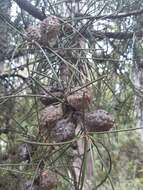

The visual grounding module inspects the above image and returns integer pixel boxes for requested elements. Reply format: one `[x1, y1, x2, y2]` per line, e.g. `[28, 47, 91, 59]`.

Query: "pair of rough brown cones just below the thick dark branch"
[26, 16, 60, 47]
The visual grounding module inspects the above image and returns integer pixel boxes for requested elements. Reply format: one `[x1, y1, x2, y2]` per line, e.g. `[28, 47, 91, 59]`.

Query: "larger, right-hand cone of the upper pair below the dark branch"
[40, 16, 60, 46]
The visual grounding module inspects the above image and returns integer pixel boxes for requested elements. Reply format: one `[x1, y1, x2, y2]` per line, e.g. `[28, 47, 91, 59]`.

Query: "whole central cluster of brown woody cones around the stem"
[40, 87, 114, 143]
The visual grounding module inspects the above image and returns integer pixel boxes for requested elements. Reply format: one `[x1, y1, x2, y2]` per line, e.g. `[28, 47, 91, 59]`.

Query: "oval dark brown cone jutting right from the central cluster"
[85, 109, 114, 132]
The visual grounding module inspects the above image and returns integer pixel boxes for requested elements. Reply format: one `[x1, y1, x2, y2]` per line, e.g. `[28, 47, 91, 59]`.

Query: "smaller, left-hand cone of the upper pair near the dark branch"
[26, 26, 41, 44]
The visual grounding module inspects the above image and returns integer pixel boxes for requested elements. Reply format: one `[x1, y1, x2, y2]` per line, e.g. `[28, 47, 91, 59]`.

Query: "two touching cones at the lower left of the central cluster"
[40, 104, 75, 142]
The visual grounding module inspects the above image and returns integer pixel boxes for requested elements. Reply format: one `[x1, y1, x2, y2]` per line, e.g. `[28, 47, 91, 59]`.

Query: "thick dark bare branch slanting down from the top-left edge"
[14, 0, 46, 20]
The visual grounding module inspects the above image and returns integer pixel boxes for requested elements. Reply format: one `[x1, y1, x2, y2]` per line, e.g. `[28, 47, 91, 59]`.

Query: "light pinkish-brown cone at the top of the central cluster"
[67, 87, 91, 110]
